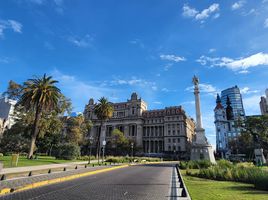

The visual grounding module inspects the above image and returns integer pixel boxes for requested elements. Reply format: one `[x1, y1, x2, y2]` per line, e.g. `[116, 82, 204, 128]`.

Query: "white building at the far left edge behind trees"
[0, 97, 17, 134]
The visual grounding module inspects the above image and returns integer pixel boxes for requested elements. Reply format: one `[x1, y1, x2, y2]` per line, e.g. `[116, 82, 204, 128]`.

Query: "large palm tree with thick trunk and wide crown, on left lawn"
[18, 74, 61, 158]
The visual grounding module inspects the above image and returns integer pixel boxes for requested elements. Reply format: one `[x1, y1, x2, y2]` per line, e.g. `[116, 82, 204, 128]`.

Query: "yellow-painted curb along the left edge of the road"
[0, 165, 130, 195]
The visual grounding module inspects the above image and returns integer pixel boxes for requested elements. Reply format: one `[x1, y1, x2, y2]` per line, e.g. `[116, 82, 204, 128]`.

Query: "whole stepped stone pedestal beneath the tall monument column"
[191, 128, 216, 163]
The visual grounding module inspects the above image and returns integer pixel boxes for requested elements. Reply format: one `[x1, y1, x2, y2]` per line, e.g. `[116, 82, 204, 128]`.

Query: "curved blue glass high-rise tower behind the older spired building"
[221, 85, 245, 120]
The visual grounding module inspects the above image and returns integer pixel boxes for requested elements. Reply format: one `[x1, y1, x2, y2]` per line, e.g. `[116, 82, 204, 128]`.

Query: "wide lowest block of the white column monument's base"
[191, 143, 216, 163]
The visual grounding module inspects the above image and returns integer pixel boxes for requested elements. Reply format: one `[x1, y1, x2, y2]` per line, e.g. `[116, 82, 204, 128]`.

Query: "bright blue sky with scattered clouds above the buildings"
[0, 0, 268, 148]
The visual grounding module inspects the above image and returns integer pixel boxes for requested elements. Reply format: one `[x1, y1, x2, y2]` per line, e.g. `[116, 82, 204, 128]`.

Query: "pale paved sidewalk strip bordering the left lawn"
[0, 160, 98, 174]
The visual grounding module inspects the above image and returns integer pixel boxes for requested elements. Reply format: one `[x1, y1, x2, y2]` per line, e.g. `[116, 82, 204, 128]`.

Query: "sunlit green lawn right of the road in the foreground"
[181, 170, 268, 200]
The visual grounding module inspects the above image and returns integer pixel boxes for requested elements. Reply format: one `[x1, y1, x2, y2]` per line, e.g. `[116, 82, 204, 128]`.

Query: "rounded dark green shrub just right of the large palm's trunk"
[55, 143, 80, 160]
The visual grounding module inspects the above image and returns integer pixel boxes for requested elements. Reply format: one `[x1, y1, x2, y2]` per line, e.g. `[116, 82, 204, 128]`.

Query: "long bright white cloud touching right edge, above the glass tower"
[196, 52, 268, 73]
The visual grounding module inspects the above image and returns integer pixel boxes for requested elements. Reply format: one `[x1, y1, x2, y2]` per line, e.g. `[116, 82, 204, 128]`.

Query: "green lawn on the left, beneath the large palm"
[0, 156, 81, 168]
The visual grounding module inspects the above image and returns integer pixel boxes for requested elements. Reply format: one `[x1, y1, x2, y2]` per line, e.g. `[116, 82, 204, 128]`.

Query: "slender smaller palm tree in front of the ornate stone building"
[94, 97, 114, 163]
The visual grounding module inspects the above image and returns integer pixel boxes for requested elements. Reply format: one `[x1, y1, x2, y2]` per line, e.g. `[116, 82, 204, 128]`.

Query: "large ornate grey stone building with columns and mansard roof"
[84, 93, 195, 157]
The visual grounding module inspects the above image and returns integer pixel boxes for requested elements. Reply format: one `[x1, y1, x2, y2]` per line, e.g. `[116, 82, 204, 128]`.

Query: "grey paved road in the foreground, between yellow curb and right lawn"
[0, 164, 174, 200]
